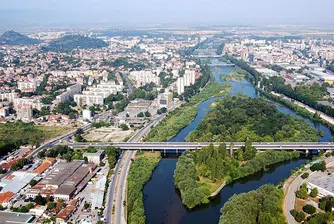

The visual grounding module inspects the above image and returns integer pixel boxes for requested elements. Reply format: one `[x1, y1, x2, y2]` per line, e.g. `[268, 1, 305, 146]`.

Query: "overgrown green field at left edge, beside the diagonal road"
[0, 121, 45, 156]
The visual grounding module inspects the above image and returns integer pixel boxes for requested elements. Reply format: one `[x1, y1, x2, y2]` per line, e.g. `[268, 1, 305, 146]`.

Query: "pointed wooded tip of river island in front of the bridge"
[174, 144, 299, 208]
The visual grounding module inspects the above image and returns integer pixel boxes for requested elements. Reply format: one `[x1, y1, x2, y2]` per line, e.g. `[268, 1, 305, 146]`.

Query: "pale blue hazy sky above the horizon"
[0, 0, 334, 27]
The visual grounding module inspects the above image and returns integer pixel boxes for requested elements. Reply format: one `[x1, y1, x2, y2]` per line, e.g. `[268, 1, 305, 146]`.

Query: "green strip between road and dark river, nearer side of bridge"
[127, 152, 161, 224]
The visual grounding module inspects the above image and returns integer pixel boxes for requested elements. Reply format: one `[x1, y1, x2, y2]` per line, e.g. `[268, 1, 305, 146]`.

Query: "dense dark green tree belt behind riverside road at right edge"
[262, 77, 334, 116]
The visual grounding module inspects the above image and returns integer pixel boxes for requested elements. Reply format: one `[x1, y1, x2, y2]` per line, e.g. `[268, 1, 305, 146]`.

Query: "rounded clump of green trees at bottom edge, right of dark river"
[219, 185, 285, 224]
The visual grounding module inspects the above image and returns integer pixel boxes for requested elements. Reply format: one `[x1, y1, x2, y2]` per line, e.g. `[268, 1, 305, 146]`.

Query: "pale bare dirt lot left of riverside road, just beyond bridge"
[83, 127, 134, 142]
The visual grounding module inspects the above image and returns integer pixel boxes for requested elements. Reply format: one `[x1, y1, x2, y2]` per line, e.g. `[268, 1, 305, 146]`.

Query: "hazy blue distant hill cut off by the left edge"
[0, 31, 40, 45]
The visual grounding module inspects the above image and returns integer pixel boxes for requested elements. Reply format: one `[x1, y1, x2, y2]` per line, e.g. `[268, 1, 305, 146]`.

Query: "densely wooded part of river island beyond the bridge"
[187, 95, 317, 142]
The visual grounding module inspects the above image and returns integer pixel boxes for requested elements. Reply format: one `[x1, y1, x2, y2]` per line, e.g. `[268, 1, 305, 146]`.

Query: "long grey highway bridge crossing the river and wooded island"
[69, 141, 334, 151]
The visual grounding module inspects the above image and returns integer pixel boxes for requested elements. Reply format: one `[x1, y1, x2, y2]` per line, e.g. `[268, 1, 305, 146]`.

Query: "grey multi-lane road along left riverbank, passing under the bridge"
[105, 115, 165, 224]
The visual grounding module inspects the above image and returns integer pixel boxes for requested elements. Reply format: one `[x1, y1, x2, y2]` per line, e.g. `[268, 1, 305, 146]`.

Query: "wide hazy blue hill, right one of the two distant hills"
[44, 35, 108, 51]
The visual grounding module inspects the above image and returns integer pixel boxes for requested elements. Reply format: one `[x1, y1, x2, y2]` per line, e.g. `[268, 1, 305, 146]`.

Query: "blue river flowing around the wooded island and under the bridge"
[143, 62, 331, 224]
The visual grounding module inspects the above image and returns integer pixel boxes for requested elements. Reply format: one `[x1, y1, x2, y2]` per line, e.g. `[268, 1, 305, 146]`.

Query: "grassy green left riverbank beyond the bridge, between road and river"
[145, 81, 230, 142]
